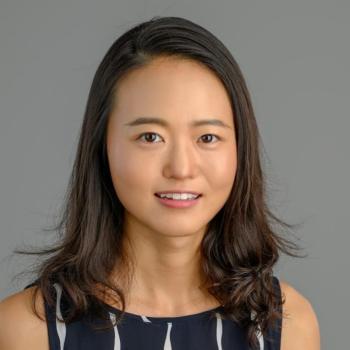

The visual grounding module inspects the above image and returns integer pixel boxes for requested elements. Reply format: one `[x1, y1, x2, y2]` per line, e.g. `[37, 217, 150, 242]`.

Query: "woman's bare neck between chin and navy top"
[109, 219, 218, 315]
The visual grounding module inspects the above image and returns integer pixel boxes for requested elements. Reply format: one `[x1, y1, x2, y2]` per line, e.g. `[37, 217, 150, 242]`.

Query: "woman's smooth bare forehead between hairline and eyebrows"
[112, 57, 233, 129]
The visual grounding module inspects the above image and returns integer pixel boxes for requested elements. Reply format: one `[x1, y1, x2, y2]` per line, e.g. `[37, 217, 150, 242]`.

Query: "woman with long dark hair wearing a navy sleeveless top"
[0, 17, 320, 350]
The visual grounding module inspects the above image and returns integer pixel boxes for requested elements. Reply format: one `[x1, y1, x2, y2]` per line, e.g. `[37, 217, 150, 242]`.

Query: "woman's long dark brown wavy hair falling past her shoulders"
[15, 16, 305, 347]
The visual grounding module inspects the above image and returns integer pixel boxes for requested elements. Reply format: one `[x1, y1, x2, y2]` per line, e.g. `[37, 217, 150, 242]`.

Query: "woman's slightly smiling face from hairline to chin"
[107, 58, 237, 241]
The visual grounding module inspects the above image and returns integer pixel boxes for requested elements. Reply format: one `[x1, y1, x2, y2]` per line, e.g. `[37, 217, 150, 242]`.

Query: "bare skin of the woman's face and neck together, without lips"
[107, 58, 237, 315]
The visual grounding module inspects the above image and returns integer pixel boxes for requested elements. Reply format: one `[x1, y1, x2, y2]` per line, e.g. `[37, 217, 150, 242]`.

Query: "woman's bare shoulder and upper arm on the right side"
[280, 280, 321, 350]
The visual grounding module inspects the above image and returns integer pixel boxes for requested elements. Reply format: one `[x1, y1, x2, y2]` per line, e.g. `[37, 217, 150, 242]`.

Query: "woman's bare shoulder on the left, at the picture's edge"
[0, 287, 49, 350]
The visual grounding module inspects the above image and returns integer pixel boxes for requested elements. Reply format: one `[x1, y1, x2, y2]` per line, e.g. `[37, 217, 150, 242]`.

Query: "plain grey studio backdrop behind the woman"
[0, 0, 350, 349]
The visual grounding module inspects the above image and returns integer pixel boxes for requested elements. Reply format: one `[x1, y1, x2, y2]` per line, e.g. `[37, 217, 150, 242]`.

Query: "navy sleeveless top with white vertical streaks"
[24, 276, 282, 350]
